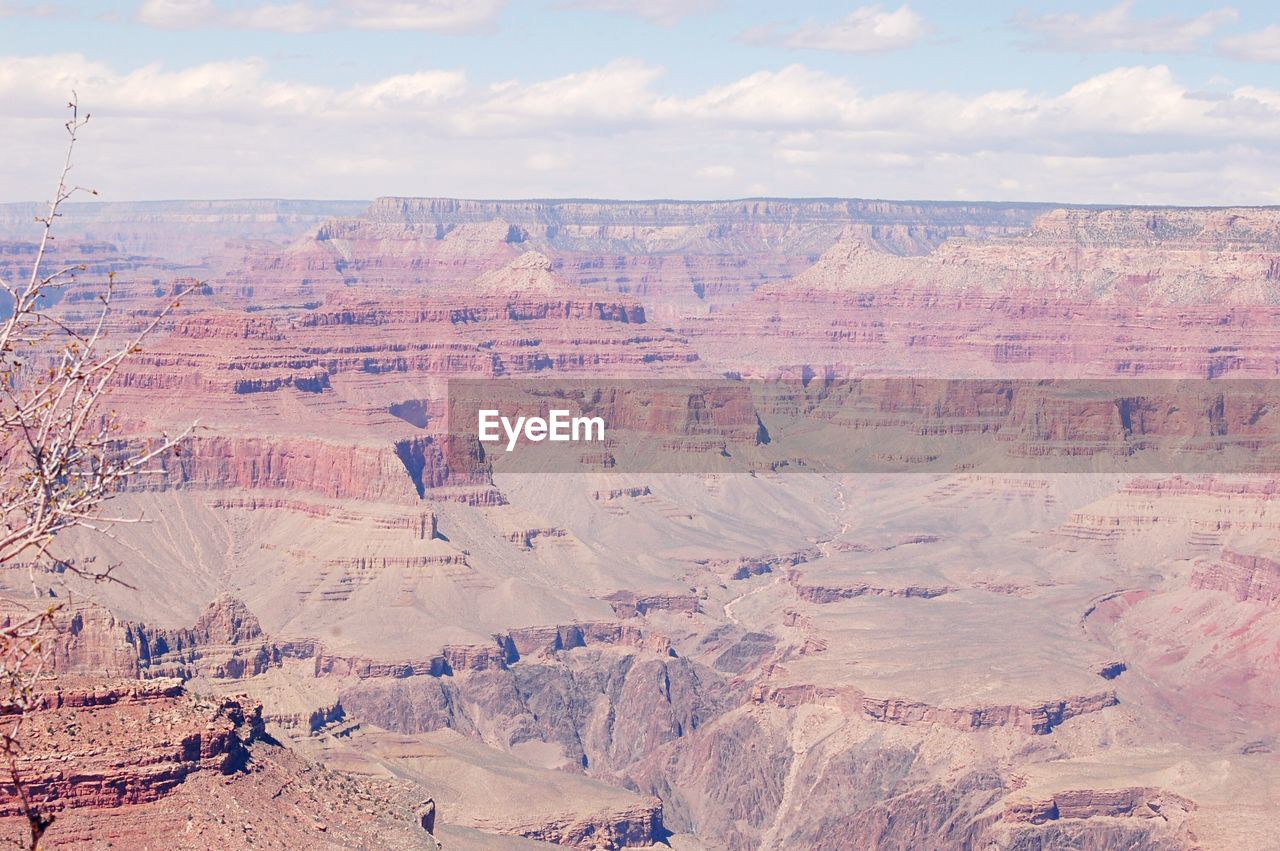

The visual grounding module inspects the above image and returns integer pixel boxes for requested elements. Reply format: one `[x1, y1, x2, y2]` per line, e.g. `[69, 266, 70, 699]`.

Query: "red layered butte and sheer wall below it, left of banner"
[96, 252, 698, 504]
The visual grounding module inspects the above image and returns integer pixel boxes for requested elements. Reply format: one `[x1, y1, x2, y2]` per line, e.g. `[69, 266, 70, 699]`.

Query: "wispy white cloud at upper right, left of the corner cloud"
[1014, 0, 1238, 54]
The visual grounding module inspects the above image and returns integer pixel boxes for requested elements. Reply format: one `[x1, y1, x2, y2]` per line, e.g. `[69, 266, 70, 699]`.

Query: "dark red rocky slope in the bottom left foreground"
[0, 676, 438, 848]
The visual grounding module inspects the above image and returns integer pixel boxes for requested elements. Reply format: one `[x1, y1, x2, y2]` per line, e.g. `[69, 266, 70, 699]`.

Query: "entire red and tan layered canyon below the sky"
[0, 198, 1280, 851]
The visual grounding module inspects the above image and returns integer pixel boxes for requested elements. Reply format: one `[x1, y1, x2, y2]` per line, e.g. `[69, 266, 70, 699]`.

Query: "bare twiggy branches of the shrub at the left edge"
[0, 93, 192, 848]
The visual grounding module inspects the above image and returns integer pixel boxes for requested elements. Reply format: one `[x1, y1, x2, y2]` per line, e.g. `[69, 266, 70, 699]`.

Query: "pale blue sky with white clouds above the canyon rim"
[0, 0, 1280, 205]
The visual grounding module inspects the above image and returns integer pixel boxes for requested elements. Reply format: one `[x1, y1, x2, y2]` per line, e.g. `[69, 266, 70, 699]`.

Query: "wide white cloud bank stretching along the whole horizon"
[0, 55, 1280, 203]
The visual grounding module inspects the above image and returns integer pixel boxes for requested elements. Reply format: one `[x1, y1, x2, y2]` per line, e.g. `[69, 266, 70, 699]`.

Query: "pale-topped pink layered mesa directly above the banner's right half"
[678, 278, 1280, 379]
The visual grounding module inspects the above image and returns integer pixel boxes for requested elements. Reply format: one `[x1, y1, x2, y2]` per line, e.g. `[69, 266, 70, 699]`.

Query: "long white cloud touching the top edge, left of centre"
[137, 0, 506, 32]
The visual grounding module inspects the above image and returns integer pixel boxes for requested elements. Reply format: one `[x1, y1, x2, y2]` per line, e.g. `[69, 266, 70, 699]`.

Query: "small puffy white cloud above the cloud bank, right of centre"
[740, 5, 931, 54]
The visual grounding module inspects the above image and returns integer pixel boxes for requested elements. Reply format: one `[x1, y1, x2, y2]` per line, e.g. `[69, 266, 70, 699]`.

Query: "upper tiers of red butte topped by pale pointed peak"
[207, 252, 698, 381]
